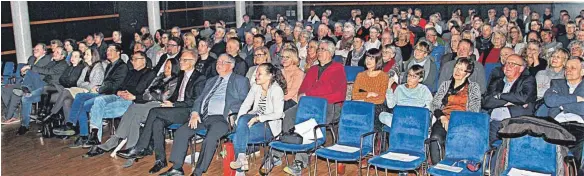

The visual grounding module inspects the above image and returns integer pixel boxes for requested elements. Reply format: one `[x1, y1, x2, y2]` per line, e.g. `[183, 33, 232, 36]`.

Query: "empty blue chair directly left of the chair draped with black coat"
[428, 111, 489, 175]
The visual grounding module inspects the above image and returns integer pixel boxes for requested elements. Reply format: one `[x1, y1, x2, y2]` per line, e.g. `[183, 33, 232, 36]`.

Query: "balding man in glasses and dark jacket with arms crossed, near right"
[482, 54, 537, 142]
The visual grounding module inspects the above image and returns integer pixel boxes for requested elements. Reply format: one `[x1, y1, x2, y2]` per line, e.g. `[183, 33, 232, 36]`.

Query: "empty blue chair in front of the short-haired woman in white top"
[367, 106, 431, 175]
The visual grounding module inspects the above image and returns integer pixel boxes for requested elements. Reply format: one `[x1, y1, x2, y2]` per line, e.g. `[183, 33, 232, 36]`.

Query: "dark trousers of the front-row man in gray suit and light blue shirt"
[169, 115, 229, 175]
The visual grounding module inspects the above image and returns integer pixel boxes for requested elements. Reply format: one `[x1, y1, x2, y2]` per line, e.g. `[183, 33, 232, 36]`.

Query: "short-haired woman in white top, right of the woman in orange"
[379, 65, 432, 127]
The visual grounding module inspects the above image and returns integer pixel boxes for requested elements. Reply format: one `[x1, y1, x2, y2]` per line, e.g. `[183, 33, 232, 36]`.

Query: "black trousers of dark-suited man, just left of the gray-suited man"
[136, 107, 191, 161]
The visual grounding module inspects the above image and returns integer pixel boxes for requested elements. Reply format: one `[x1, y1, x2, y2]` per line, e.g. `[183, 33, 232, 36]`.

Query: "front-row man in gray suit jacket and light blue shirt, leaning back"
[118, 54, 249, 175]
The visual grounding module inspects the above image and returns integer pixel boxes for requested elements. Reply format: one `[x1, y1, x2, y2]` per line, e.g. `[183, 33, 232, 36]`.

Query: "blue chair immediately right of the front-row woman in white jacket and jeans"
[269, 96, 327, 175]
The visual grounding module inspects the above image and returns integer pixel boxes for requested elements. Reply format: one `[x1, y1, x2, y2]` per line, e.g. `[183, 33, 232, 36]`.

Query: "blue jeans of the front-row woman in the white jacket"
[233, 114, 274, 156]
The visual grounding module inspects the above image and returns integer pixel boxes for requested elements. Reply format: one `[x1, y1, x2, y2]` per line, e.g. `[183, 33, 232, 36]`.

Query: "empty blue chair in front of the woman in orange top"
[314, 101, 375, 175]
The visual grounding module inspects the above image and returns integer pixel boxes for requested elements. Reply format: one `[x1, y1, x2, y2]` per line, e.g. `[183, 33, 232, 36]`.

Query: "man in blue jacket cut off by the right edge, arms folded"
[543, 58, 584, 168]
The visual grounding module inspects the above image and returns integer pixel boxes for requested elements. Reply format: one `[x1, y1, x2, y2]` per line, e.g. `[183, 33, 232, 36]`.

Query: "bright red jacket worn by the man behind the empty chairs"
[298, 61, 347, 104]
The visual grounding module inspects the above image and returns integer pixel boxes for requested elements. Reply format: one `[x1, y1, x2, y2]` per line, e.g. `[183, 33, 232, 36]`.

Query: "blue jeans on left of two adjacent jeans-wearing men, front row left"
[68, 93, 99, 136]
